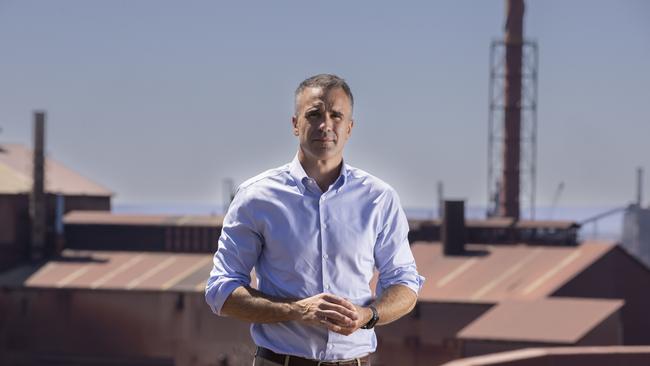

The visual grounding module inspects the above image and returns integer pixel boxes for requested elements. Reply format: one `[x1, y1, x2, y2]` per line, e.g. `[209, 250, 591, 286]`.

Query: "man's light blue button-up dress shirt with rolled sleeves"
[205, 157, 424, 360]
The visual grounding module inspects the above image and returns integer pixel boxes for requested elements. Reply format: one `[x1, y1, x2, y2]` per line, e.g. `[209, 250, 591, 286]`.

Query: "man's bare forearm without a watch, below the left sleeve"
[221, 286, 299, 323]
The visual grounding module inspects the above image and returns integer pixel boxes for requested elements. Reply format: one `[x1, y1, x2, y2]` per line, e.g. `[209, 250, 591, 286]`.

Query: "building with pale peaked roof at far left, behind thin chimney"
[0, 144, 113, 271]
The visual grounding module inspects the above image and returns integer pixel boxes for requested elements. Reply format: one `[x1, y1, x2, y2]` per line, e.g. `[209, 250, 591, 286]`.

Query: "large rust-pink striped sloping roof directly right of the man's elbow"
[411, 242, 615, 303]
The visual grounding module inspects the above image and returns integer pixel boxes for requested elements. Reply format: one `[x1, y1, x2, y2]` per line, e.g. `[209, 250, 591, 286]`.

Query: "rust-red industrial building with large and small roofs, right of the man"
[378, 242, 650, 365]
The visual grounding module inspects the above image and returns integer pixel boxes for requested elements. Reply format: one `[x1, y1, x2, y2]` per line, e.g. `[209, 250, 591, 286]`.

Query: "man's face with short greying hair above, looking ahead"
[292, 88, 354, 160]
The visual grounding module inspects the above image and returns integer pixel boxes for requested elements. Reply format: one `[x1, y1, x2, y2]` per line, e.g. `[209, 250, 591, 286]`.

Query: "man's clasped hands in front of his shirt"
[294, 293, 372, 335]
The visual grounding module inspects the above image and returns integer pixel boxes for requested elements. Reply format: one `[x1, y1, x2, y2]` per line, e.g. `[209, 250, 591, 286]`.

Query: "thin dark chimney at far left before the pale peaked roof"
[29, 111, 46, 261]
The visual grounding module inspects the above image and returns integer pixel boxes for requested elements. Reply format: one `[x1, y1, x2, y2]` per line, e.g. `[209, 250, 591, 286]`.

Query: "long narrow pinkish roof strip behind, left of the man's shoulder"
[63, 211, 223, 227]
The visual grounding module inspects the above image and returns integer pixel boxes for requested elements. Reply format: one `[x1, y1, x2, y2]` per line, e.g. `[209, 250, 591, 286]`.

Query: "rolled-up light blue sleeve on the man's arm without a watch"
[205, 189, 262, 315]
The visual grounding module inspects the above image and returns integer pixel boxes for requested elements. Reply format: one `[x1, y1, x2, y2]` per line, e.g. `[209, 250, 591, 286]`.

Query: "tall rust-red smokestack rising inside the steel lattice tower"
[499, 0, 524, 219]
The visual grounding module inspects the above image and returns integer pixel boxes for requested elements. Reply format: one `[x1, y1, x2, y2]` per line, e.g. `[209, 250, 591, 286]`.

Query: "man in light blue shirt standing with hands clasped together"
[205, 74, 424, 366]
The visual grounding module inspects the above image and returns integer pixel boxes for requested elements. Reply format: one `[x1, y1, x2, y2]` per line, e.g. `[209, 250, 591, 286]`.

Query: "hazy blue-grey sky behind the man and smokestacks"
[0, 0, 650, 213]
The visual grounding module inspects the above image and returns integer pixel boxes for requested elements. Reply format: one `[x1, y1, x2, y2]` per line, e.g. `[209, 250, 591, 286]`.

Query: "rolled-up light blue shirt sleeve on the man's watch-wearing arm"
[374, 189, 424, 297]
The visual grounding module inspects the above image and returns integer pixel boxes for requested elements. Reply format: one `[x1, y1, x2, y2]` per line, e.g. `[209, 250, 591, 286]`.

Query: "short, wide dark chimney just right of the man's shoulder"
[440, 201, 466, 255]
